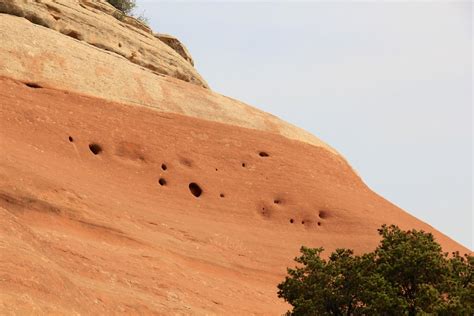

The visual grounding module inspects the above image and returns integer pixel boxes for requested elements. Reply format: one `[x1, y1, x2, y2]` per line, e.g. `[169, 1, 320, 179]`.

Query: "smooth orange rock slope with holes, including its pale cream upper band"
[0, 0, 469, 315]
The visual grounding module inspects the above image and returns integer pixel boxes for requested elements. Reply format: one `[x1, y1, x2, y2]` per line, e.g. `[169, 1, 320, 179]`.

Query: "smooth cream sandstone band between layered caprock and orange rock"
[0, 14, 336, 153]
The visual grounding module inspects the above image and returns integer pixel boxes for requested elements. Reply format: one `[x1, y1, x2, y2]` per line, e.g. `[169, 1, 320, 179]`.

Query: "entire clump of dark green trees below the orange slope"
[278, 225, 474, 315]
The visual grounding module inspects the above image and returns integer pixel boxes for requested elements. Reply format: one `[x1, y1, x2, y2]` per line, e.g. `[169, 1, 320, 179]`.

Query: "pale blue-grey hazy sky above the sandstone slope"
[137, 0, 474, 249]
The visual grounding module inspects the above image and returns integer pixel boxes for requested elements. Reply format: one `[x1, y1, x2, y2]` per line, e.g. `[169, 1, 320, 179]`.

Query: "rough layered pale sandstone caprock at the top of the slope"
[0, 0, 208, 87]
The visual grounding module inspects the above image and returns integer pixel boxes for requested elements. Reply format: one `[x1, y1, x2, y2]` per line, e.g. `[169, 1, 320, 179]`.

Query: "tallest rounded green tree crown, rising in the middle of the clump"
[375, 225, 448, 316]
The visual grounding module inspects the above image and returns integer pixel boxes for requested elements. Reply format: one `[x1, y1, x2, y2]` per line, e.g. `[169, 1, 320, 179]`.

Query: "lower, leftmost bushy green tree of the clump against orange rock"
[278, 247, 398, 315]
